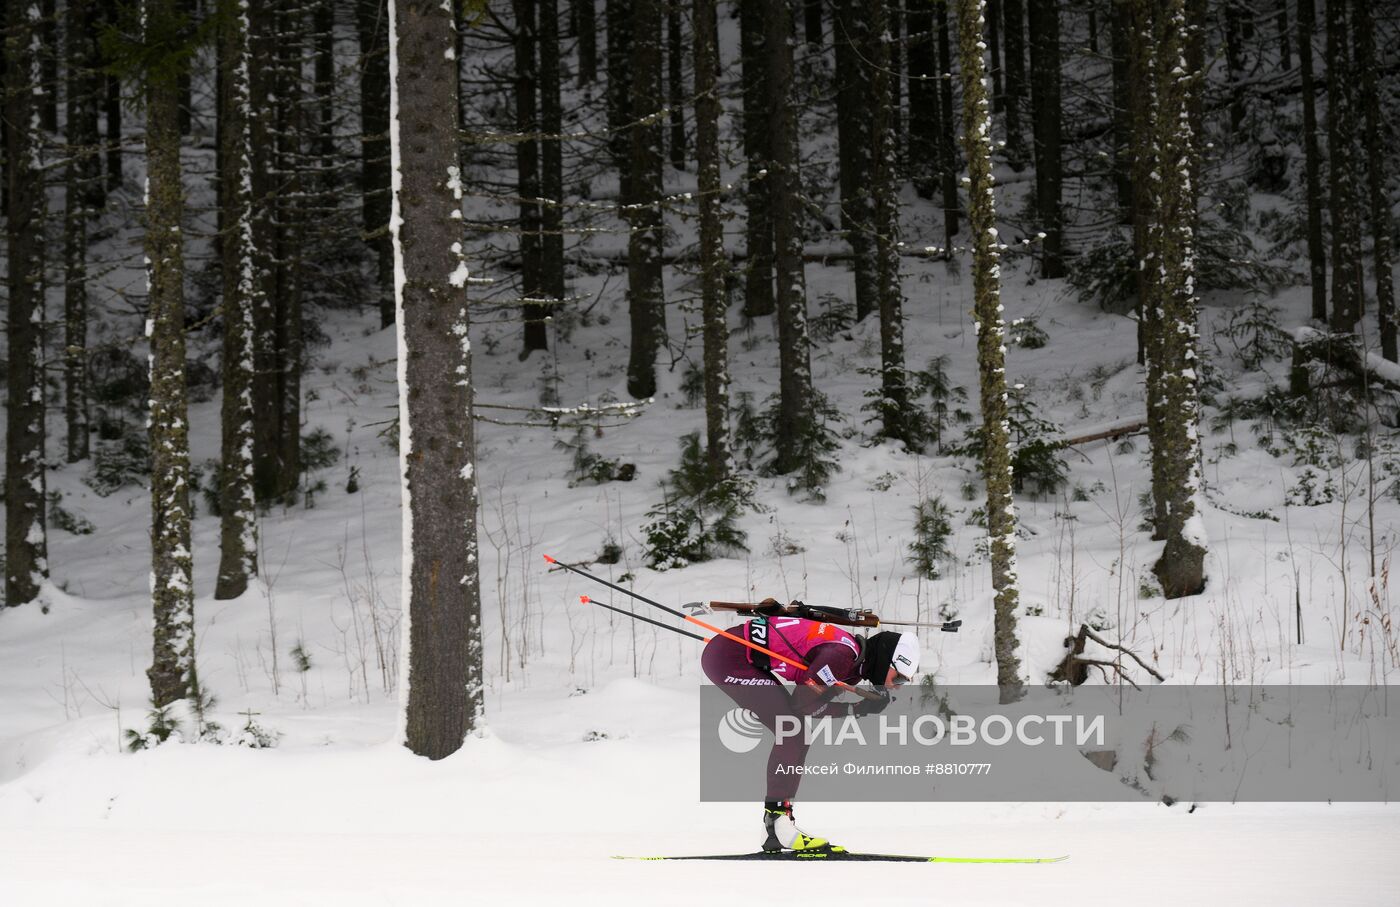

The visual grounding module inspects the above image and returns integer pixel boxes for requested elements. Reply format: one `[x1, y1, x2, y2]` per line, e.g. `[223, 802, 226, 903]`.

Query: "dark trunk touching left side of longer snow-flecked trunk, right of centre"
[832, 0, 868, 321]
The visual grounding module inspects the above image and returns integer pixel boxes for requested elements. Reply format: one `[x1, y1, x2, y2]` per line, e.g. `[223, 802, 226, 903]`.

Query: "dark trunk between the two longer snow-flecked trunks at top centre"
[739, 0, 777, 318]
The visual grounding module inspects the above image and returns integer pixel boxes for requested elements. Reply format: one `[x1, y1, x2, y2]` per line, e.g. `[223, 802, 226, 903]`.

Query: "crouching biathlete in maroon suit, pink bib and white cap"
[700, 604, 918, 852]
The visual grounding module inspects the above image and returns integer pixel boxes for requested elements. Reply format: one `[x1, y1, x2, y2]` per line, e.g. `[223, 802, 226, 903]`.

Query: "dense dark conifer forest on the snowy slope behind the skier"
[0, 0, 1400, 834]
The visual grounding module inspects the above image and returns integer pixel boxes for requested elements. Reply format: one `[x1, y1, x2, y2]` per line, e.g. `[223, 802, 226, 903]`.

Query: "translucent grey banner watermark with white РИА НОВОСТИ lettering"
[700, 686, 1400, 802]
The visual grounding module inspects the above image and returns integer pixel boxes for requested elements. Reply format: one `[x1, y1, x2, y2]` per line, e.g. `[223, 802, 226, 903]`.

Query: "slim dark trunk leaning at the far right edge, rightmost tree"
[1351, 0, 1396, 363]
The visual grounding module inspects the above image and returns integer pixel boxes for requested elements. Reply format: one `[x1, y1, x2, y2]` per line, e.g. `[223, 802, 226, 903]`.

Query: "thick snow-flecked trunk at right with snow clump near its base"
[1144, 0, 1205, 598]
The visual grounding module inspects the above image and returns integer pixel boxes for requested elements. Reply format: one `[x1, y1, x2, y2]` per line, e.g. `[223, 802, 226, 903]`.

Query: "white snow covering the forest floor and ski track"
[0, 7, 1400, 906]
